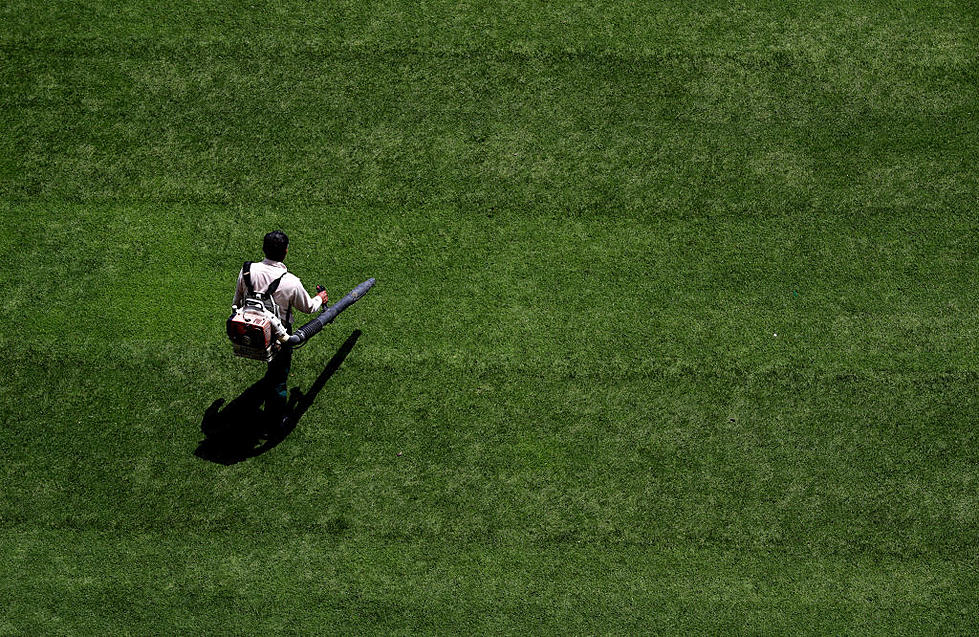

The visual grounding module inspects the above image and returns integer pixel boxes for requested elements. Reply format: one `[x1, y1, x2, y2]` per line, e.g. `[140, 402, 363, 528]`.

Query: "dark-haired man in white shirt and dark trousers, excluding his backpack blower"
[232, 230, 327, 429]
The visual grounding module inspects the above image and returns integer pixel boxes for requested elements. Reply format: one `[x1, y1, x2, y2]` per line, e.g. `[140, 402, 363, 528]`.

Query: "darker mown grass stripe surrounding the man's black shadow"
[0, 335, 977, 558]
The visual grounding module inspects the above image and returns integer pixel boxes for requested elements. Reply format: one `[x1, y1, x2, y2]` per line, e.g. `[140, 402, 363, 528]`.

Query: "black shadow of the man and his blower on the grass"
[194, 330, 360, 465]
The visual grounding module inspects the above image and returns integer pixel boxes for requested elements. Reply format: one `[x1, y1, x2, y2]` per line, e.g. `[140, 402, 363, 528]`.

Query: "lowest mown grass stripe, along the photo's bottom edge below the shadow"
[0, 532, 976, 634]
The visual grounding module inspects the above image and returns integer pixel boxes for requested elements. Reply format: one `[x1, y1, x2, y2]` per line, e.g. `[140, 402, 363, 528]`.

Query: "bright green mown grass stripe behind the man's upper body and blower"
[0, 205, 979, 376]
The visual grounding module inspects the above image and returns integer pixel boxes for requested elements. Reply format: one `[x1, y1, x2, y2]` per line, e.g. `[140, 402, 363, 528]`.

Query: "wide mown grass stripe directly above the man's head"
[0, 23, 977, 207]
